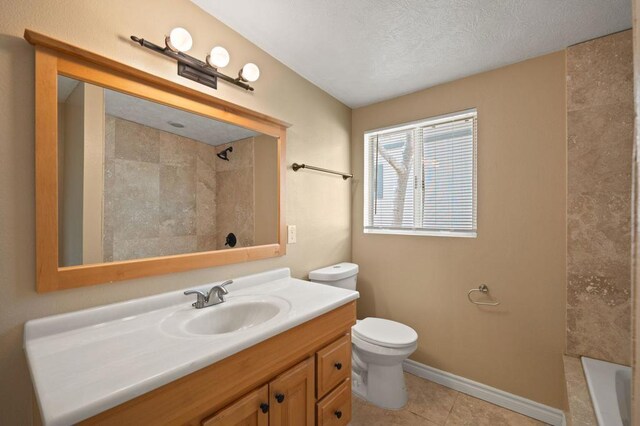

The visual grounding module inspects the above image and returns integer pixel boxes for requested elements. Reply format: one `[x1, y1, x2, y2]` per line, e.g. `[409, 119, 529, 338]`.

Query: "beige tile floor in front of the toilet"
[351, 374, 544, 426]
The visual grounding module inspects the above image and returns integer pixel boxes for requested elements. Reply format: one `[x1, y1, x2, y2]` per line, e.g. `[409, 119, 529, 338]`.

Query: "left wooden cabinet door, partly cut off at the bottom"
[202, 385, 269, 426]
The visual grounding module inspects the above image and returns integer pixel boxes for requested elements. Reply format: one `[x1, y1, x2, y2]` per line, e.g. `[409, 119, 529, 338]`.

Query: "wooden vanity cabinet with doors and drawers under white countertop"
[80, 302, 356, 426]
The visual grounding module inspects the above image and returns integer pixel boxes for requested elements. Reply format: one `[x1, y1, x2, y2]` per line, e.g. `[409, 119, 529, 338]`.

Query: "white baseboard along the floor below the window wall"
[403, 359, 566, 426]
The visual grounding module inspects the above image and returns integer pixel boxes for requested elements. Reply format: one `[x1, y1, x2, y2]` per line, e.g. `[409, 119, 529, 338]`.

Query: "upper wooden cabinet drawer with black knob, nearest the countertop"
[316, 334, 351, 399]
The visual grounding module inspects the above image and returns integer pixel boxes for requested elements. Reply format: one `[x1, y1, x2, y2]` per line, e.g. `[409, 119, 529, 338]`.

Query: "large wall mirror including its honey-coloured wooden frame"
[25, 30, 289, 292]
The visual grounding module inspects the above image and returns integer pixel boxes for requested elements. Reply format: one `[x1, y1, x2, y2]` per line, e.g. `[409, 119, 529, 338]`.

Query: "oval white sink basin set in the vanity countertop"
[160, 296, 290, 337]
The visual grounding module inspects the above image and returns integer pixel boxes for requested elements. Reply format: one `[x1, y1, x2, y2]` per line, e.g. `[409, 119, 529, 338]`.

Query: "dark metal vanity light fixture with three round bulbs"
[131, 27, 260, 92]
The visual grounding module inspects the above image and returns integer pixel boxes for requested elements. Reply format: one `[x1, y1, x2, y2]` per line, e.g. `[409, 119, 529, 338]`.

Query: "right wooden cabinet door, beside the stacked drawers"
[269, 358, 315, 426]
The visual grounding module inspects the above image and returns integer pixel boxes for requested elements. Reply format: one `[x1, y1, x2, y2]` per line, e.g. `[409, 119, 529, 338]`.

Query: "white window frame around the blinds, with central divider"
[362, 108, 478, 238]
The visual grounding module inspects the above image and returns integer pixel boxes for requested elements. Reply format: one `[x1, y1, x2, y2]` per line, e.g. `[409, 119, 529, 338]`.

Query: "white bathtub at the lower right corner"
[582, 357, 631, 426]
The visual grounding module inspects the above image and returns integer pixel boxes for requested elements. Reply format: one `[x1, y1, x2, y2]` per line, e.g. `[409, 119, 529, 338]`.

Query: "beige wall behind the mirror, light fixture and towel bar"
[0, 0, 351, 425]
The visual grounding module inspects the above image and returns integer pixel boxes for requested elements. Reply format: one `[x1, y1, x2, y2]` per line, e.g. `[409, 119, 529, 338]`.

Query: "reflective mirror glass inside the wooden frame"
[58, 75, 278, 267]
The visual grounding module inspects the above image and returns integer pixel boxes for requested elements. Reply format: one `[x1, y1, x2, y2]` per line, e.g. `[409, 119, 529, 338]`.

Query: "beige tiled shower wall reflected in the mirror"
[103, 116, 254, 262]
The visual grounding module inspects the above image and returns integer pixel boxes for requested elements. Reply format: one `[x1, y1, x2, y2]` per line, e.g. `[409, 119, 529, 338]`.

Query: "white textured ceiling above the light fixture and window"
[192, 0, 631, 107]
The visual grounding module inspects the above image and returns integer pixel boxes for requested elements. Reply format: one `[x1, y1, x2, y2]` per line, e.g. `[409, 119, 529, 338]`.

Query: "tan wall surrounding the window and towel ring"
[351, 52, 566, 407]
